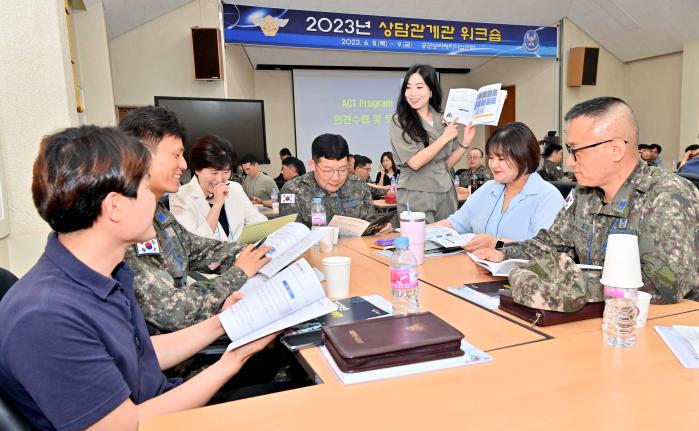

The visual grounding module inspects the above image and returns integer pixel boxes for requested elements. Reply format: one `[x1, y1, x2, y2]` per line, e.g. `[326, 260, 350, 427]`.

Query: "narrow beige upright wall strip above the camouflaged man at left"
[71, 2, 116, 126]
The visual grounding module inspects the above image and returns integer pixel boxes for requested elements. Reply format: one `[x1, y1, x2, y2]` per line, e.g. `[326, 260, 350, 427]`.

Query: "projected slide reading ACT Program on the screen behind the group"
[294, 70, 404, 173]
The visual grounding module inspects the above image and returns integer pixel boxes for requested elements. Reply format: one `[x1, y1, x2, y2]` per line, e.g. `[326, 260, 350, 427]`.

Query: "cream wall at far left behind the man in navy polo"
[0, 0, 78, 275]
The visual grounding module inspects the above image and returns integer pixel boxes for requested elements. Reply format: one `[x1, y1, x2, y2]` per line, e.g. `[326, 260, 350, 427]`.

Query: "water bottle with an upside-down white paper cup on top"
[602, 286, 638, 347]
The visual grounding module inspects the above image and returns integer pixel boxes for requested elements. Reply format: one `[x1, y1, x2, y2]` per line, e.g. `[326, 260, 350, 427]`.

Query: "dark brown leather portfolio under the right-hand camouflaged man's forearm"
[499, 290, 604, 326]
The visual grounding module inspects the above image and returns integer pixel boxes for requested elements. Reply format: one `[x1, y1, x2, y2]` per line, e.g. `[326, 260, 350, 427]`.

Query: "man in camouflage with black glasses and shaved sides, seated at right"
[476, 97, 699, 311]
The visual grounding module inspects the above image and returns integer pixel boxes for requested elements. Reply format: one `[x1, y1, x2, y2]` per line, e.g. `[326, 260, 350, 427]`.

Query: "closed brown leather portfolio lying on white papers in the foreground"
[323, 312, 464, 373]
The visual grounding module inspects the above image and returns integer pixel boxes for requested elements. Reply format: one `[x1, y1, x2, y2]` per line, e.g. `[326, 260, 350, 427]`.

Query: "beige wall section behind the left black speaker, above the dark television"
[109, 0, 225, 105]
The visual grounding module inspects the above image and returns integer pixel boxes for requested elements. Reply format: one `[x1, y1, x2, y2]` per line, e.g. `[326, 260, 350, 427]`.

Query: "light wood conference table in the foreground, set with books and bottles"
[139, 238, 699, 430]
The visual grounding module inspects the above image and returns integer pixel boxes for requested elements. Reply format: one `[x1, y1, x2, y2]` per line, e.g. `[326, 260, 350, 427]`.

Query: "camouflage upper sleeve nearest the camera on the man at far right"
[638, 190, 699, 304]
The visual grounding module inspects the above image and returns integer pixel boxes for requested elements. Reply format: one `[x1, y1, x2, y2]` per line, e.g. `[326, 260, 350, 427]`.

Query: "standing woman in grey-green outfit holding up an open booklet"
[390, 64, 475, 223]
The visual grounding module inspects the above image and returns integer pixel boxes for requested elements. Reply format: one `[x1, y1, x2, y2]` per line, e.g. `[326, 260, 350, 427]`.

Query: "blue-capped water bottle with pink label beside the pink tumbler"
[390, 236, 420, 314]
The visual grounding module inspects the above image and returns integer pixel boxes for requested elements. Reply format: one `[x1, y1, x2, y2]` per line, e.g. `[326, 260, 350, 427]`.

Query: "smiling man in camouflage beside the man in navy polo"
[119, 106, 268, 331]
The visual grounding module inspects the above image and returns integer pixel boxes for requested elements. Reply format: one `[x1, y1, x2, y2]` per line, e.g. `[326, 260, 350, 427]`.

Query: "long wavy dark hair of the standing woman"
[393, 64, 442, 147]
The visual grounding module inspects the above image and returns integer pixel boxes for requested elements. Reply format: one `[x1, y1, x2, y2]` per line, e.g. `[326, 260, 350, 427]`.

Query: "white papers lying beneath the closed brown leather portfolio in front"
[320, 340, 493, 384]
